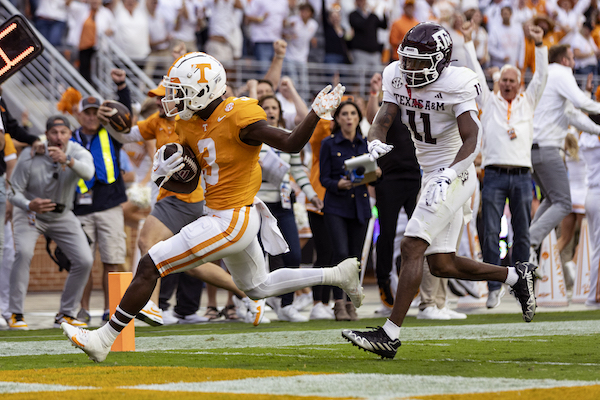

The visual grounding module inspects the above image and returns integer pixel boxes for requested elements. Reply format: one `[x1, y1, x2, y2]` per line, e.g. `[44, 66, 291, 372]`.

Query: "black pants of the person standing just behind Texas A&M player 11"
[375, 179, 421, 287]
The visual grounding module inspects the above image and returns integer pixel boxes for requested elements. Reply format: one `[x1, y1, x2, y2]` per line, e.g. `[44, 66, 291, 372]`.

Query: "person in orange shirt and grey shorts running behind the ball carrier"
[98, 84, 251, 325]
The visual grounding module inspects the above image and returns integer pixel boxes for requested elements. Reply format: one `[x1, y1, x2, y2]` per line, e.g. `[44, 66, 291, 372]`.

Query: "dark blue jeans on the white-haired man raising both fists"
[481, 168, 533, 291]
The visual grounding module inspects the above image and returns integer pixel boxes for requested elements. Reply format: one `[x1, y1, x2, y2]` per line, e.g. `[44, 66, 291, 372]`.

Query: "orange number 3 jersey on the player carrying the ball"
[175, 97, 267, 210]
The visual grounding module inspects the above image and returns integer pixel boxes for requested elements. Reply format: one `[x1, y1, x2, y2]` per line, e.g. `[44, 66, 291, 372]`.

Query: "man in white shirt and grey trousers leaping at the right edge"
[529, 45, 600, 261]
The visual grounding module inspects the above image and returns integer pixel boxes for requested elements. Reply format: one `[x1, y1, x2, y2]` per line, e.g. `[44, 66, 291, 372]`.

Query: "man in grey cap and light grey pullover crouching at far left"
[8, 115, 95, 330]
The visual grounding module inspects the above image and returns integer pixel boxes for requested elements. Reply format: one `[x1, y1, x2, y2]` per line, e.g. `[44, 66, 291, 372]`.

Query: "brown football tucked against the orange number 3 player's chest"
[155, 143, 200, 194]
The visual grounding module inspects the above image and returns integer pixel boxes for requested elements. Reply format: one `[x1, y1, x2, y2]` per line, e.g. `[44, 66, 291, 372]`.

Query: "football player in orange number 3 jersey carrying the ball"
[61, 52, 364, 362]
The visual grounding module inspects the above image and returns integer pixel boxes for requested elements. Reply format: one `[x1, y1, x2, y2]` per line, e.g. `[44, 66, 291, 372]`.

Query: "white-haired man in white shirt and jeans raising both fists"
[462, 24, 548, 308]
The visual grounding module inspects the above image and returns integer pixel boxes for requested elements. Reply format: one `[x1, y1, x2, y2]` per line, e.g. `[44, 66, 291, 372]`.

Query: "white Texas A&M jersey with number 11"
[383, 61, 481, 174]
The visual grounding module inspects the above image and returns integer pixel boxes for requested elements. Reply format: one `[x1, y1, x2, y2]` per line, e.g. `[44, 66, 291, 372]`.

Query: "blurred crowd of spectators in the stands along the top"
[12, 0, 600, 82]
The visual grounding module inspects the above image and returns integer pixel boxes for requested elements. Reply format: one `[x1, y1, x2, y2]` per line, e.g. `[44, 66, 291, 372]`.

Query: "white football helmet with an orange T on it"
[162, 52, 227, 120]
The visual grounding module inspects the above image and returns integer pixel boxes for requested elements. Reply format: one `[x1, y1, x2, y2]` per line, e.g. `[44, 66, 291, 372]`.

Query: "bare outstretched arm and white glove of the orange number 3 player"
[240, 85, 346, 153]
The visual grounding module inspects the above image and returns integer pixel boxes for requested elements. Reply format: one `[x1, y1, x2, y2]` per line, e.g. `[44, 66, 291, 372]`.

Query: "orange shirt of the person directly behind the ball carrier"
[138, 111, 204, 203]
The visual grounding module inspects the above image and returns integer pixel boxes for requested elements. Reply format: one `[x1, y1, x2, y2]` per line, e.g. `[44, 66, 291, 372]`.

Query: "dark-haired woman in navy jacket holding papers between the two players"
[320, 101, 381, 321]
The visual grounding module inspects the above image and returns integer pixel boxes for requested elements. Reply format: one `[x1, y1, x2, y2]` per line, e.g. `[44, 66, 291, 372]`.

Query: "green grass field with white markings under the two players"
[0, 311, 600, 400]
